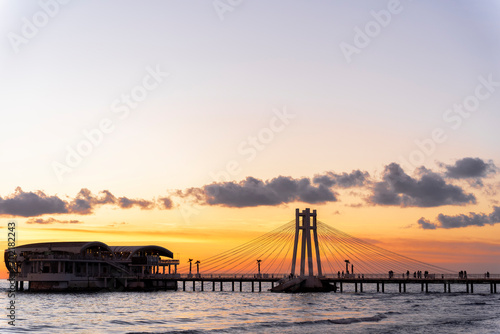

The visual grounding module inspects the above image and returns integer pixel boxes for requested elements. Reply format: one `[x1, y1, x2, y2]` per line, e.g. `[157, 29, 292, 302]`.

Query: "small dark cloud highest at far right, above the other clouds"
[445, 158, 497, 179]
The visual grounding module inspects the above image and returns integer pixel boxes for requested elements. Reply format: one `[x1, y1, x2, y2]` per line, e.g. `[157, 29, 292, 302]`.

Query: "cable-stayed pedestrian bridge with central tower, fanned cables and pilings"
[174, 209, 500, 293]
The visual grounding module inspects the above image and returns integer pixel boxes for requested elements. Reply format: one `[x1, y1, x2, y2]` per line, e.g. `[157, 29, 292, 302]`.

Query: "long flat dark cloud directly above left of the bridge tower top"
[198, 176, 337, 208]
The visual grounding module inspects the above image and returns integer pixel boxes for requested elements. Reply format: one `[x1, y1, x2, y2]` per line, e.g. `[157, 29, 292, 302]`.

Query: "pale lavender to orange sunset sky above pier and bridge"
[0, 0, 500, 274]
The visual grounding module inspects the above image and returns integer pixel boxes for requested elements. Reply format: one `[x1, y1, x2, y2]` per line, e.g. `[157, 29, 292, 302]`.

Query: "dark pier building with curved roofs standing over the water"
[4, 241, 179, 291]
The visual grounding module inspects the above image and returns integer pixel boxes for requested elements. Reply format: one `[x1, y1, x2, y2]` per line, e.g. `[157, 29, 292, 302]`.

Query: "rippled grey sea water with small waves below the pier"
[0, 280, 500, 334]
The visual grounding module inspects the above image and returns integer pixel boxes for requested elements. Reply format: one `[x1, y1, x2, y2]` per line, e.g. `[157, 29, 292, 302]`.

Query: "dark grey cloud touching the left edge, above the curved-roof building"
[0, 187, 68, 217]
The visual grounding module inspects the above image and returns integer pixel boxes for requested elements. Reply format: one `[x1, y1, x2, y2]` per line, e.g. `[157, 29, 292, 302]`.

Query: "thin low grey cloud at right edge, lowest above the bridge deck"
[418, 206, 500, 230]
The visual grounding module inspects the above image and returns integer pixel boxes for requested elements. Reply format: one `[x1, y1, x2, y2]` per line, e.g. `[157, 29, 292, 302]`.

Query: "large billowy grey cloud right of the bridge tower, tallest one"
[368, 163, 476, 207]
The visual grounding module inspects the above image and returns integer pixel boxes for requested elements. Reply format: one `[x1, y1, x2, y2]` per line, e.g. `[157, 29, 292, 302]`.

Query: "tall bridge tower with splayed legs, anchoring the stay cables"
[291, 208, 323, 277]
